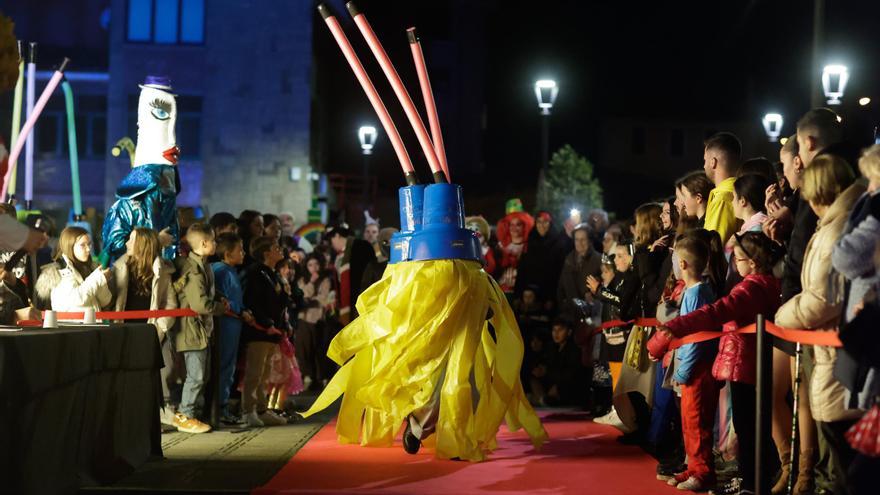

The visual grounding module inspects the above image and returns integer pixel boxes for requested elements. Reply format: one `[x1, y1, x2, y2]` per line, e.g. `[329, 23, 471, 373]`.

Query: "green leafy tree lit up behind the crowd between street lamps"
[537, 144, 602, 219]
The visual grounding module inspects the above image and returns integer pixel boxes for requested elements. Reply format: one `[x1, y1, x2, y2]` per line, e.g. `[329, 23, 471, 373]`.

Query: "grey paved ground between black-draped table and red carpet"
[79, 397, 336, 495]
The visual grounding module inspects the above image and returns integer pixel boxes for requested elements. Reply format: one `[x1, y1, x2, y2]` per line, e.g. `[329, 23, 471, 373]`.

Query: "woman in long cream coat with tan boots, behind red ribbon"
[776, 155, 865, 493]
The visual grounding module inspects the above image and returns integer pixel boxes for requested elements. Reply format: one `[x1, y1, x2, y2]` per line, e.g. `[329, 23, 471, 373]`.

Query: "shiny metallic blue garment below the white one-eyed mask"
[101, 164, 180, 263]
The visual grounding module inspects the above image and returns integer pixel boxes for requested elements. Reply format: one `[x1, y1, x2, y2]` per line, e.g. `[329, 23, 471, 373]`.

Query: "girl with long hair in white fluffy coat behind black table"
[36, 227, 113, 312]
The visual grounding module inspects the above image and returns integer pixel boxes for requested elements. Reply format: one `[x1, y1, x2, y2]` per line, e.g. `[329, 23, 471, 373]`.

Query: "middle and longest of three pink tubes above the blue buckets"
[345, 2, 449, 182]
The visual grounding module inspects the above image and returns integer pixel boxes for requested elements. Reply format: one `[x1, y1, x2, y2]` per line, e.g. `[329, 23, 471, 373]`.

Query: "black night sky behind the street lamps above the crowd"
[315, 0, 880, 219]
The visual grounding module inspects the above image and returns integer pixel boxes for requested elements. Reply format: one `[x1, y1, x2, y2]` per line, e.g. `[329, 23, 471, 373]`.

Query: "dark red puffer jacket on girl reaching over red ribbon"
[666, 274, 781, 384]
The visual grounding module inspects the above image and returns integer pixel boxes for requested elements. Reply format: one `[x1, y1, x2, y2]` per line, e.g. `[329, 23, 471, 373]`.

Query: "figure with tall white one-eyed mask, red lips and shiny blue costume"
[101, 76, 180, 263]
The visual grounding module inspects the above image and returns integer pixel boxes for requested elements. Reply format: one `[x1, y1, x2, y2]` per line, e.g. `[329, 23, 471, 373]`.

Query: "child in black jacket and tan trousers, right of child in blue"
[242, 236, 290, 426]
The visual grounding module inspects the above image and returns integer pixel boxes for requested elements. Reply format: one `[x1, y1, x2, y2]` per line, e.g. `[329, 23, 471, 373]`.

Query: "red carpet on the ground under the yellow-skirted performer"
[253, 412, 687, 495]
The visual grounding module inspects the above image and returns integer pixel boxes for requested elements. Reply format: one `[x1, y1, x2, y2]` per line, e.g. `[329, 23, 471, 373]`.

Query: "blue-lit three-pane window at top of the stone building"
[127, 0, 205, 45]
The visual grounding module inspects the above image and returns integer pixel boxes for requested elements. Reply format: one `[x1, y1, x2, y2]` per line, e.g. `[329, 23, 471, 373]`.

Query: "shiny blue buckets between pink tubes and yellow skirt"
[388, 184, 483, 264]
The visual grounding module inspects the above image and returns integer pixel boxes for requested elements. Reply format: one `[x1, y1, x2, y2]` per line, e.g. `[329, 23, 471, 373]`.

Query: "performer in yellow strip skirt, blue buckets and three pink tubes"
[303, 3, 547, 461]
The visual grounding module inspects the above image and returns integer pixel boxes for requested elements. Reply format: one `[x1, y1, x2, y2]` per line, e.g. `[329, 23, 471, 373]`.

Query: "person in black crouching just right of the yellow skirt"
[531, 320, 585, 406]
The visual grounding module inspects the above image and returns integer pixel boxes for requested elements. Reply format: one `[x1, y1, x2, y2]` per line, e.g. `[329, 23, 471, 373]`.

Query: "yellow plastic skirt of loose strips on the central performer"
[303, 260, 547, 461]
